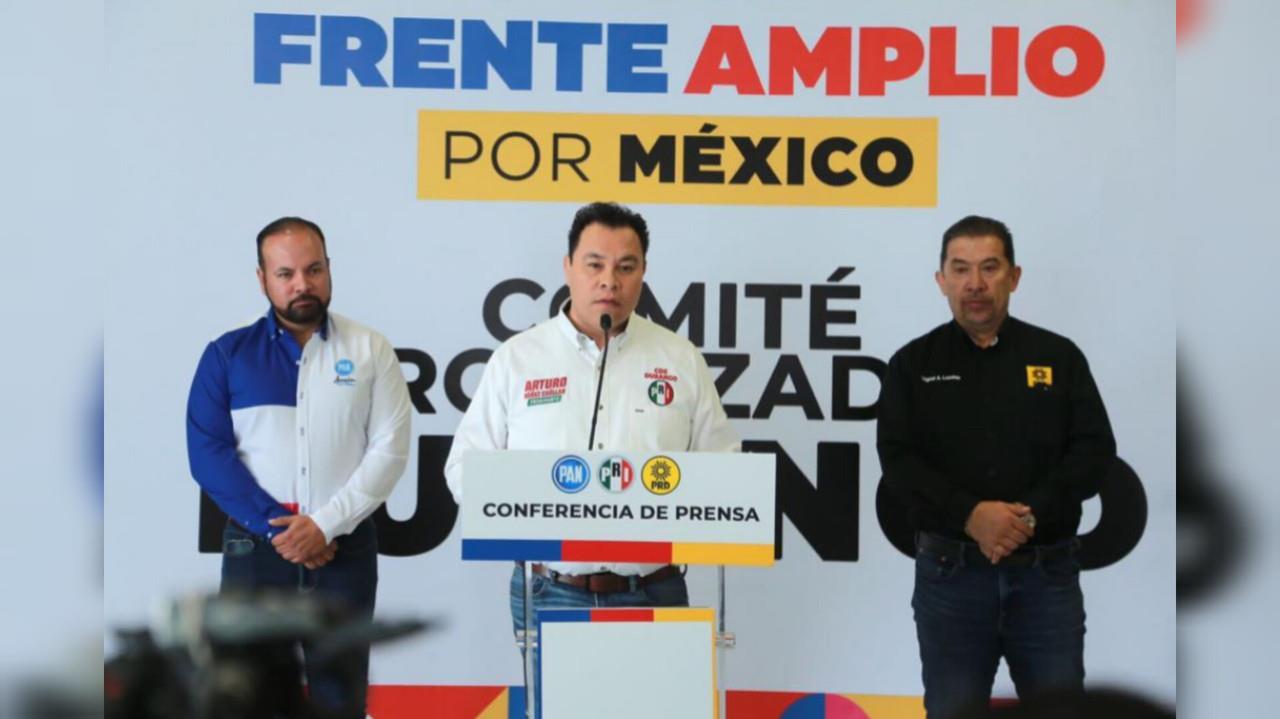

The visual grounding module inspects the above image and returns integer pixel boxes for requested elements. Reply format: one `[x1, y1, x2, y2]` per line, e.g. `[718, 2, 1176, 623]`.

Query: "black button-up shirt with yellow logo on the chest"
[876, 317, 1116, 544]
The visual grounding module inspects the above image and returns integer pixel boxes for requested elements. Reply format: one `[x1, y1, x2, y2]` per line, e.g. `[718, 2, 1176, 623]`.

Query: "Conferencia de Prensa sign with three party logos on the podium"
[460, 450, 774, 565]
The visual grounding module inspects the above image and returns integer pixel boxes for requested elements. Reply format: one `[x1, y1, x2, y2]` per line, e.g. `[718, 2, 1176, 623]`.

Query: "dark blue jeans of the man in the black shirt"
[911, 539, 1084, 719]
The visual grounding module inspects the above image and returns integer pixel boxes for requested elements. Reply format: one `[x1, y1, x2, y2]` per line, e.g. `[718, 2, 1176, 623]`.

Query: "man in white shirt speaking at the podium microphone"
[444, 197, 742, 649]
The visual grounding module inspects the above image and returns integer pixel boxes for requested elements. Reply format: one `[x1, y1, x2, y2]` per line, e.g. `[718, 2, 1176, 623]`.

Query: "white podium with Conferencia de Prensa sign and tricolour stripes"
[460, 450, 776, 719]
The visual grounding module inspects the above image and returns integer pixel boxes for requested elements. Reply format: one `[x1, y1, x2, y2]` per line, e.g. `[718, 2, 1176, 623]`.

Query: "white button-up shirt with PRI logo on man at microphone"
[444, 307, 742, 574]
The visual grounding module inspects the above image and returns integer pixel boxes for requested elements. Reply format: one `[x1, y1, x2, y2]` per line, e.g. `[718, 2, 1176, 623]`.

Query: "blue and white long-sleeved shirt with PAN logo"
[187, 310, 410, 541]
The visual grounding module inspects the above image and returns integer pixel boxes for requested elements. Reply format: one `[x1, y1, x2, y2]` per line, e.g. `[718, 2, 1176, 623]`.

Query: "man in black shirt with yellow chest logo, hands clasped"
[877, 216, 1115, 719]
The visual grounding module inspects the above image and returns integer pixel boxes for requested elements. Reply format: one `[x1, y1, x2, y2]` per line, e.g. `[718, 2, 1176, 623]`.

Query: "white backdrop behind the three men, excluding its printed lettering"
[104, 0, 1175, 701]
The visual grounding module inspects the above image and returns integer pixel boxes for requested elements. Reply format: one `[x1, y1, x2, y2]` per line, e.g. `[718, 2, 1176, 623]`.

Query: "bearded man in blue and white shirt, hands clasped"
[187, 217, 410, 716]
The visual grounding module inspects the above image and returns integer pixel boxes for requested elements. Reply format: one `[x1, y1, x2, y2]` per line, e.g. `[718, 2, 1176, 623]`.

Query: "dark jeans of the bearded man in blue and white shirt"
[221, 519, 378, 719]
